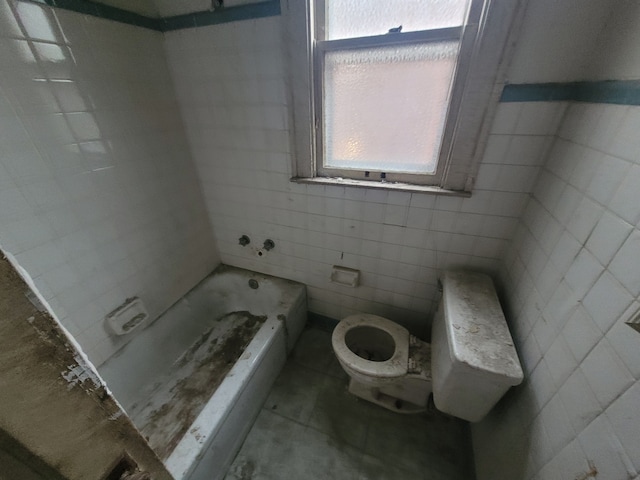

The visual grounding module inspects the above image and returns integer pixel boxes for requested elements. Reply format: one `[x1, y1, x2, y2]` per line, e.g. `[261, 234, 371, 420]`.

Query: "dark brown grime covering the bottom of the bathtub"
[136, 311, 267, 460]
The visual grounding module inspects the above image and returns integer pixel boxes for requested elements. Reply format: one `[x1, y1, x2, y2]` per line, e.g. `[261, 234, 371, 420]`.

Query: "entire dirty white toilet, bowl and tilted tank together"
[331, 272, 523, 422]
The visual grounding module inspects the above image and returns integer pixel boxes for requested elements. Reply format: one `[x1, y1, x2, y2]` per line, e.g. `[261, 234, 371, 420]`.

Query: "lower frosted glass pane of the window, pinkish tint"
[323, 42, 458, 173]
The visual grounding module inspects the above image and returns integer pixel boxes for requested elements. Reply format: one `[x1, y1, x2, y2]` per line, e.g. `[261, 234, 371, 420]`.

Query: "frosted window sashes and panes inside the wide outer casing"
[314, 0, 467, 183]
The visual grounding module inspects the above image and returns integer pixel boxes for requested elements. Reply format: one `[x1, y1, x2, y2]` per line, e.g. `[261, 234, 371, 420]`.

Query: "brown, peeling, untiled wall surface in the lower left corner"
[0, 256, 171, 480]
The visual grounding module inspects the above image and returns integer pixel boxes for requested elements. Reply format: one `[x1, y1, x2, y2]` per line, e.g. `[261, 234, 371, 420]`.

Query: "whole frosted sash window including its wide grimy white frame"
[288, 0, 517, 191]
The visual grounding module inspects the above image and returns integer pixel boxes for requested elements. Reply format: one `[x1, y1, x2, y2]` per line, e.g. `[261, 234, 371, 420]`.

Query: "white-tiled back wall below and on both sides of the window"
[165, 17, 564, 334]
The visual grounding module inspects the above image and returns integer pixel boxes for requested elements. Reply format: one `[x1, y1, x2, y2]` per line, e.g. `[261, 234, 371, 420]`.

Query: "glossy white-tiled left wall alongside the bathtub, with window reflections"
[0, 0, 218, 365]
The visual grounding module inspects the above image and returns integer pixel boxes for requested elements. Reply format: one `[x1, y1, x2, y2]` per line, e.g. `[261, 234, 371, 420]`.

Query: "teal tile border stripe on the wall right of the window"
[500, 80, 640, 105]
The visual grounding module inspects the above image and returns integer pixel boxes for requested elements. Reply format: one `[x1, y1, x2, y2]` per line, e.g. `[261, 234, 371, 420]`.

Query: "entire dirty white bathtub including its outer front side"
[99, 265, 307, 480]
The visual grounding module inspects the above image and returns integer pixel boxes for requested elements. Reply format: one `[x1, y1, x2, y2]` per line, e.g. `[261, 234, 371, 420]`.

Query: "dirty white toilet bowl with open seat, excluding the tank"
[331, 313, 431, 413]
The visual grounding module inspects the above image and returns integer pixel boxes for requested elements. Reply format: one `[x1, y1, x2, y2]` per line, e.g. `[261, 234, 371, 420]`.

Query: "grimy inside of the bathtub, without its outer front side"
[99, 265, 306, 466]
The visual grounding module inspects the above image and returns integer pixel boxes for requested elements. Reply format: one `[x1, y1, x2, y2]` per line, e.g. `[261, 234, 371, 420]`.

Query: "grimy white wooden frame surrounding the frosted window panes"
[283, 0, 524, 194]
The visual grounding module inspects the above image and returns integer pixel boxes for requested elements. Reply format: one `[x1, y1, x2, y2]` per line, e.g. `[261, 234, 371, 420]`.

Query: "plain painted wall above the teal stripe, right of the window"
[507, 0, 640, 83]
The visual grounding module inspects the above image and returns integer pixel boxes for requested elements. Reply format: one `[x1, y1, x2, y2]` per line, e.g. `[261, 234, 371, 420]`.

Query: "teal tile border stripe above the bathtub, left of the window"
[26, 0, 281, 32]
